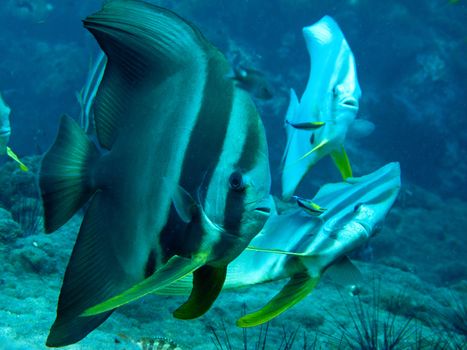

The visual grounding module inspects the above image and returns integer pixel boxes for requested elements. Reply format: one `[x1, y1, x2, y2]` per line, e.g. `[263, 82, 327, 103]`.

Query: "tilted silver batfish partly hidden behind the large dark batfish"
[157, 163, 400, 327]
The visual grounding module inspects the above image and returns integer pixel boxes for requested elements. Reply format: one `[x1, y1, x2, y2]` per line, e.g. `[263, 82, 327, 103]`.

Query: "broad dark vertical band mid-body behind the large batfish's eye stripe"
[160, 51, 233, 260]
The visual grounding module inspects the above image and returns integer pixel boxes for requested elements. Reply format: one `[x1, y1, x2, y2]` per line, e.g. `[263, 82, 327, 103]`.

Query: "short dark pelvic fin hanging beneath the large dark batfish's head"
[173, 265, 227, 320]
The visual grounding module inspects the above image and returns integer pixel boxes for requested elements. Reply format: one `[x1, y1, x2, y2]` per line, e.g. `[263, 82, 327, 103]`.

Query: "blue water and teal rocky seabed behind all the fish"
[0, 0, 467, 349]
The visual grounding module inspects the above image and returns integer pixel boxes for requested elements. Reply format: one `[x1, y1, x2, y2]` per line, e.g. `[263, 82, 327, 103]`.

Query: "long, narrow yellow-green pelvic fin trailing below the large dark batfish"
[81, 255, 205, 316]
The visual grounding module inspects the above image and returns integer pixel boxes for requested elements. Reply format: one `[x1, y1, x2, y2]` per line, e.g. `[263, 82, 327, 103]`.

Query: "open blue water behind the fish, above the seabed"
[0, 0, 467, 348]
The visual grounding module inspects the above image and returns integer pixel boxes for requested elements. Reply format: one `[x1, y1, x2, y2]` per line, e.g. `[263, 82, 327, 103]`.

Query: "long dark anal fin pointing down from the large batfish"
[47, 191, 140, 347]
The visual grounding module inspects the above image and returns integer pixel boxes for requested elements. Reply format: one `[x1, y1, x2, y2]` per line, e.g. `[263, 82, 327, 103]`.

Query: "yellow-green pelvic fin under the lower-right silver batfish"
[237, 272, 320, 327]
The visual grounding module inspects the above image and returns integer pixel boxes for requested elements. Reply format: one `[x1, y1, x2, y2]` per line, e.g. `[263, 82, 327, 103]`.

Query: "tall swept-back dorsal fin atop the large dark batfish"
[84, 0, 208, 149]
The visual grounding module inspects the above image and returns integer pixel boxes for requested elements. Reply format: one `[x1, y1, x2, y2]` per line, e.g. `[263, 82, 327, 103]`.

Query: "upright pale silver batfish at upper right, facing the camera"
[282, 16, 364, 199]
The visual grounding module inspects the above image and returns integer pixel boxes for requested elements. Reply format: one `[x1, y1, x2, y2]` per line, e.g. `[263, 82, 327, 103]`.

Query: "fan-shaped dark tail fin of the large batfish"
[39, 116, 100, 232]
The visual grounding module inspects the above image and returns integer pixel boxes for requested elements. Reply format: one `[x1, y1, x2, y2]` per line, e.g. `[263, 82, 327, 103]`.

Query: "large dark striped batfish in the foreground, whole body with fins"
[40, 0, 270, 346]
